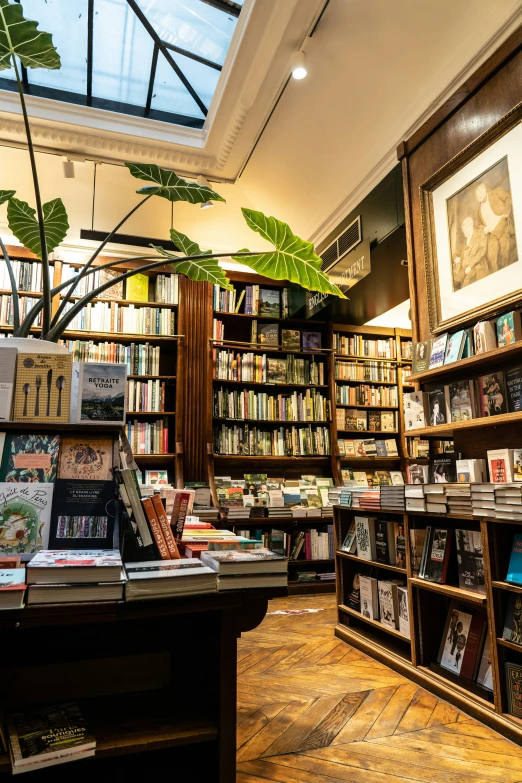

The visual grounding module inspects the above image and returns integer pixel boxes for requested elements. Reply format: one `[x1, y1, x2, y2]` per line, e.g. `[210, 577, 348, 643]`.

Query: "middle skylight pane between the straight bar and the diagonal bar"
[92, 0, 154, 106]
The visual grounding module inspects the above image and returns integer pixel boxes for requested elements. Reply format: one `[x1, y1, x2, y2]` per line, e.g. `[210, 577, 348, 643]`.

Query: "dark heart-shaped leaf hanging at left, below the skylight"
[7, 198, 69, 258]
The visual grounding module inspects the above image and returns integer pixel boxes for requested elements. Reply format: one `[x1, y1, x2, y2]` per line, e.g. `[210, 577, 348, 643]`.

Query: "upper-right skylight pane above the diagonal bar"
[138, 0, 237, 65]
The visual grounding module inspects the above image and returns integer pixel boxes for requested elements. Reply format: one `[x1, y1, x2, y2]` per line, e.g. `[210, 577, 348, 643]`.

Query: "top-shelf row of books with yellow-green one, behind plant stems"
[60, 263, 179, 305]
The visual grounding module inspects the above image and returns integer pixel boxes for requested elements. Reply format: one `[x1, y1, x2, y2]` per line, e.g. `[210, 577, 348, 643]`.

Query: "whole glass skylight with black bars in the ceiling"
[0, 0, 243, 128]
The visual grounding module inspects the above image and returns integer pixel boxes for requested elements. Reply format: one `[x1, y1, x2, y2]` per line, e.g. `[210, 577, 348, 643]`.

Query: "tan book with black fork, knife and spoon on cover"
[13, 352, 72, 424]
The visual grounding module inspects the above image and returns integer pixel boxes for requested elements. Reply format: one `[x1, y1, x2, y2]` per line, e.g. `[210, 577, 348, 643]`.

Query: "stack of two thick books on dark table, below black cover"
[27, 549, 125, 605]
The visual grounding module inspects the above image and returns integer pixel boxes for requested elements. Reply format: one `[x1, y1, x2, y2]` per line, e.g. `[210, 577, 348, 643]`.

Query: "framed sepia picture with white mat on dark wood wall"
[421, 107, 522, 334]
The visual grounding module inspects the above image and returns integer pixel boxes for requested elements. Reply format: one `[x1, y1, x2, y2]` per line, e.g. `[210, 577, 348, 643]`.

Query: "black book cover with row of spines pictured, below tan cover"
[49, 478, 117, 550]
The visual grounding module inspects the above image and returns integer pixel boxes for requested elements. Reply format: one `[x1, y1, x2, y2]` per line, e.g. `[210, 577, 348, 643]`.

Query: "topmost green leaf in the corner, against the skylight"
[0, 0, 61, 70]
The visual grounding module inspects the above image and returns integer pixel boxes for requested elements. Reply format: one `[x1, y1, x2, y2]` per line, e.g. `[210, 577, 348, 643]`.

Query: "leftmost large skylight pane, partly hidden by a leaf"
[22, 0, 87, 95]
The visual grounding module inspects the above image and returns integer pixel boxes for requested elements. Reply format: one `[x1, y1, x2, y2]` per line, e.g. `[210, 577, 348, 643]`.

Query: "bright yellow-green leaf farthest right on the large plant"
[232, 209, 346, 299]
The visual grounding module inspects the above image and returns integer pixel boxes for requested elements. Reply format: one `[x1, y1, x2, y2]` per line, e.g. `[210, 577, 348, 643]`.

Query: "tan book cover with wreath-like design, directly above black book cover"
[58, 435, 113, 481]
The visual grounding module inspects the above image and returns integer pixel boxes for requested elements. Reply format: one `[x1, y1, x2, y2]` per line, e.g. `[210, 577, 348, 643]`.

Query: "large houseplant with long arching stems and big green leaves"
[0, 0, 344, 350]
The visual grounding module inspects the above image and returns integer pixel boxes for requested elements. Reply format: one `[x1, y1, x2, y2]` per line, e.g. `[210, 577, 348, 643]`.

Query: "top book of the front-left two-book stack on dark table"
[27, 549, 123, 585]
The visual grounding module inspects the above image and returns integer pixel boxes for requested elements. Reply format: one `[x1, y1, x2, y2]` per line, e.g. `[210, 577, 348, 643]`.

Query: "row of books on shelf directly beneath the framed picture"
[413, 310, 522, 373]
